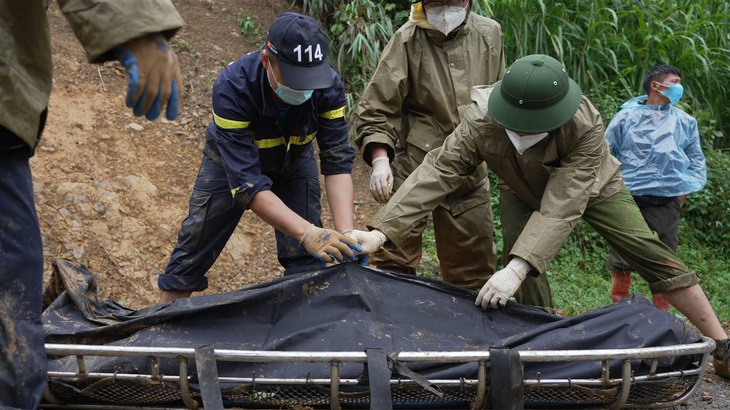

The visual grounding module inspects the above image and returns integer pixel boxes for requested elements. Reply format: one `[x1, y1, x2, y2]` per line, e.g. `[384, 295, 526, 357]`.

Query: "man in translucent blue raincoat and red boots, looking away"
[606, 65, 707, 311]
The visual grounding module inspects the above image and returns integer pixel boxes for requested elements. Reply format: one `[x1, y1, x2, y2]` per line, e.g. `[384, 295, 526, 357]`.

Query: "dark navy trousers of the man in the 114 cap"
[158, 154, 325, 291]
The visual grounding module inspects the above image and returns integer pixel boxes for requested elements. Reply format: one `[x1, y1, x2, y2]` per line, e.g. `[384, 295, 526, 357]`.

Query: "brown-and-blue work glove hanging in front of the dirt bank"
[114, 33, 182, 121]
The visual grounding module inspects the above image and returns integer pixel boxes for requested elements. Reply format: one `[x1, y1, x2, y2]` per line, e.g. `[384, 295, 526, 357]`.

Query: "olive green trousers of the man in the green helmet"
[500, 187, 700, 308]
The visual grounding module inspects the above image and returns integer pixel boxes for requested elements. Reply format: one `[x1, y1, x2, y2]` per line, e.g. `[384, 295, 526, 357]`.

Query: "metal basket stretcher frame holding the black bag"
[41, 337, 715, 410]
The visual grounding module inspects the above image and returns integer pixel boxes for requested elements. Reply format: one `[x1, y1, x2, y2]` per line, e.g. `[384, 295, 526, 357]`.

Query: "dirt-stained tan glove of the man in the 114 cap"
[299, 224, 362, 262]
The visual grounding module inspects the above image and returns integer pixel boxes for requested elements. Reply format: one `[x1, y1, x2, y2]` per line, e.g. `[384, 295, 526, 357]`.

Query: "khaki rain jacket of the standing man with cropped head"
[354, 13, 505, 214]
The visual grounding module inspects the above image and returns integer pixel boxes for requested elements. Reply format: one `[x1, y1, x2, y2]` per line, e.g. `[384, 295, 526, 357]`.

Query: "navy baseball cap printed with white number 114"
[266, 12, 334, 90]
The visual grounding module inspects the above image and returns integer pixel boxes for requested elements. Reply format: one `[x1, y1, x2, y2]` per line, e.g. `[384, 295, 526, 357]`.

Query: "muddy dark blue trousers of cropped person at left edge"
[0, 146, 46, 409]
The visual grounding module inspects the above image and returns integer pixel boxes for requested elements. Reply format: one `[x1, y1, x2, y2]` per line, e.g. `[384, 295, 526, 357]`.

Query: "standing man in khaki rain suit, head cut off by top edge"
[355, 0, 504, 289]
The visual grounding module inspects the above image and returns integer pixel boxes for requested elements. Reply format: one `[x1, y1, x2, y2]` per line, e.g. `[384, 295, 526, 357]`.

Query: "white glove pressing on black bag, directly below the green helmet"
[475, 257, 530, 309]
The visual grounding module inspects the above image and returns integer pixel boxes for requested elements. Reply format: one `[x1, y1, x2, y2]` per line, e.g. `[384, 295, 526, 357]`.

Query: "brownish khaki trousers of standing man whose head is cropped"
[371, 193, 497, 289]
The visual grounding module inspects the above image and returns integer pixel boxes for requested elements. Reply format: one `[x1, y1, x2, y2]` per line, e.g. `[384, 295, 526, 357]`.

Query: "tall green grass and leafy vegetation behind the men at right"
[294, 0, 730, 320]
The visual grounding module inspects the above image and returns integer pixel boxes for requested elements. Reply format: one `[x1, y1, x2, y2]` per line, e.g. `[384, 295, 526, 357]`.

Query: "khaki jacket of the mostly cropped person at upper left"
[0, 0, 183, 148]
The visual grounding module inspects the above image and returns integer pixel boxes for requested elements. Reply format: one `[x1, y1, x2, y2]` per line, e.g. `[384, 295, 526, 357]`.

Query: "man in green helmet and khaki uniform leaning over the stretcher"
[353, 55, 730, 377]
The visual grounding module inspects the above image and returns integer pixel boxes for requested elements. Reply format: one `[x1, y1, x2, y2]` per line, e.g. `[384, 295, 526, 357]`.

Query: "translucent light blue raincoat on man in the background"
[606, 95, 707, 197]
